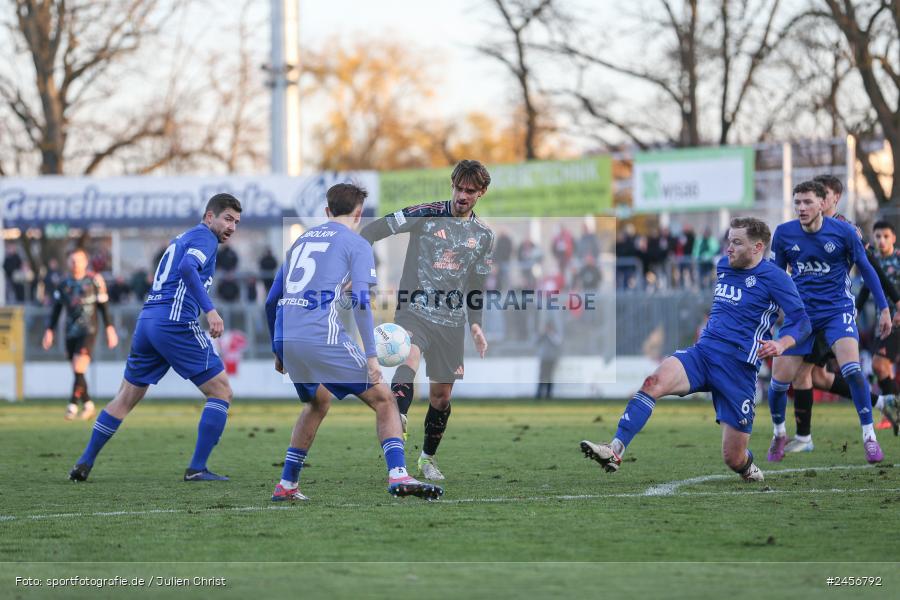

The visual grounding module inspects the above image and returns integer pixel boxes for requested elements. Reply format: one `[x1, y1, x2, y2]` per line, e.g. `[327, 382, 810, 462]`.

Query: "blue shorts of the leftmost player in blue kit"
[125, 318, 225, 387]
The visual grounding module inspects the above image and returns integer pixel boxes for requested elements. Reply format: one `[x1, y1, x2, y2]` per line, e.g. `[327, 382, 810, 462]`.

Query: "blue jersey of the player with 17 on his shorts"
[772, 217, 887, 321]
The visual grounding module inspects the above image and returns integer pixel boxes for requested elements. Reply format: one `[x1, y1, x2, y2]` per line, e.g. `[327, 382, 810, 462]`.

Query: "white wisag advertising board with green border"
[634, 147, 754, 212]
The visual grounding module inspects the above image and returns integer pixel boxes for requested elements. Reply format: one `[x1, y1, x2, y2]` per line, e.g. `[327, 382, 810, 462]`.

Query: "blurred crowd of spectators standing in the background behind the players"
[3, 224, 752, 304]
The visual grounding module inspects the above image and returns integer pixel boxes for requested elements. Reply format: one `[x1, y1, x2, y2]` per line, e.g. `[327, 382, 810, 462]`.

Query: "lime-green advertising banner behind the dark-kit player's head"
[378, 156, 612, 217]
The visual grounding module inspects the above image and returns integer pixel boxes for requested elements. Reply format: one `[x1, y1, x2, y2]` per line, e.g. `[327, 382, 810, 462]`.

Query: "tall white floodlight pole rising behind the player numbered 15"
[263, 0, 301, 175]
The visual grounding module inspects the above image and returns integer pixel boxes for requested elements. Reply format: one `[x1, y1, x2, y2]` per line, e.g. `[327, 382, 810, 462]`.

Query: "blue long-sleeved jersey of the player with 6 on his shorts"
[697, 257, 810, 365]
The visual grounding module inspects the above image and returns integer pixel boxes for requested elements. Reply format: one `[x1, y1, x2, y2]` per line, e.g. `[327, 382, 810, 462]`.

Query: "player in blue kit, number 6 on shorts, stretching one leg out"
[581, 217, 810, 481]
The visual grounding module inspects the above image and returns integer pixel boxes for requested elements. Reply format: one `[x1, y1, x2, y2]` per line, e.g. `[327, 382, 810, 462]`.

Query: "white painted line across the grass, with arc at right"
[0, 474, 900, 522]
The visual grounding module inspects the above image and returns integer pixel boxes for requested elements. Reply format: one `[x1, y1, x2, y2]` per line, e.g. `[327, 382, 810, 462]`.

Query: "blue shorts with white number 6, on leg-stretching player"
[673, 346, 757, 433]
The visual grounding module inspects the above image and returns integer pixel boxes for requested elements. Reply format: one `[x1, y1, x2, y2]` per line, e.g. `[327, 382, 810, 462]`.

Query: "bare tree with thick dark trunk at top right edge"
[819, 0, 900, 203]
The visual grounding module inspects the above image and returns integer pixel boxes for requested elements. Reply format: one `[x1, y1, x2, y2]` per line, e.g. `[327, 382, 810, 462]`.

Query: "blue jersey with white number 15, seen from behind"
[267, 221, 377, 356]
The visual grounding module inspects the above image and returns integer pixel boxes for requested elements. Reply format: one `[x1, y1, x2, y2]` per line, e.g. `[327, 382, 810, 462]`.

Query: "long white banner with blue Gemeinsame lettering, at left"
[0, 171, 379, 228]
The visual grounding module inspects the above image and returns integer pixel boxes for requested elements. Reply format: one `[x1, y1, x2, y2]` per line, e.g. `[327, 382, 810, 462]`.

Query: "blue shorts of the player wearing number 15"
[275, 335, 372, 402]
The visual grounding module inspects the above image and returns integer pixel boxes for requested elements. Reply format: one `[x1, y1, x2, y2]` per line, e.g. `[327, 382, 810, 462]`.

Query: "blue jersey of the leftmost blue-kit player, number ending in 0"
[141, 223, 219, 323]
